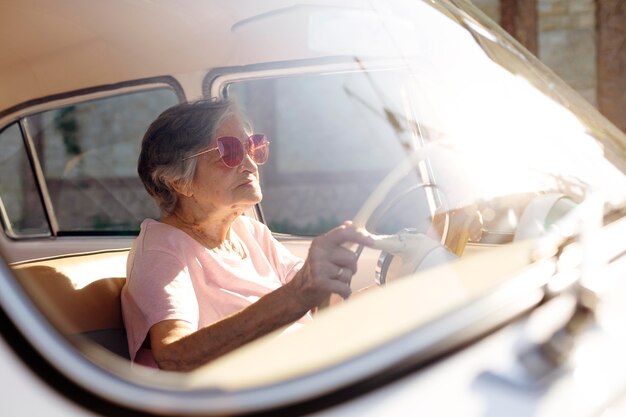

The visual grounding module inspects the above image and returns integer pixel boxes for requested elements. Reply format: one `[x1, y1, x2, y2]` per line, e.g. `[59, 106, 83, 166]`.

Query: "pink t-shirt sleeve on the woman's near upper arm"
[124, 250, 199, 357]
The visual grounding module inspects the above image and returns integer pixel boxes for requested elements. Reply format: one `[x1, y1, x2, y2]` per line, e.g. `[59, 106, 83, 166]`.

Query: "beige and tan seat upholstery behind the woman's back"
[12, 250, 128, 356]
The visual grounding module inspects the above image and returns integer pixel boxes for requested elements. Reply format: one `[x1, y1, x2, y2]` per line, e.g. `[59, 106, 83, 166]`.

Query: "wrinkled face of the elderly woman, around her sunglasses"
[186, 117, 263, 214]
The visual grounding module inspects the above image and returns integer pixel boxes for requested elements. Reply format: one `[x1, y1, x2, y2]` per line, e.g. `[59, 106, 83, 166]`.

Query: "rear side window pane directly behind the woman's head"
[27, 88, 178, 234]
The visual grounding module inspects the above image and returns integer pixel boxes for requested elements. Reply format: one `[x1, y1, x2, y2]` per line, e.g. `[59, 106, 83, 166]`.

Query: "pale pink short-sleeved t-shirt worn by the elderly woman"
[122, 216, 310, 367]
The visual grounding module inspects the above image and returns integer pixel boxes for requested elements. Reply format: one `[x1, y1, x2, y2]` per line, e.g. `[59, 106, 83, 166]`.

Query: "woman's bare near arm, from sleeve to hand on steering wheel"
[150, 224, 372, 371]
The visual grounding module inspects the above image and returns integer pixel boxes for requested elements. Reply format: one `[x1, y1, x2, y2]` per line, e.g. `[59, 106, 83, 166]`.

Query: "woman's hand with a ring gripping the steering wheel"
[287, 222, 373, 309]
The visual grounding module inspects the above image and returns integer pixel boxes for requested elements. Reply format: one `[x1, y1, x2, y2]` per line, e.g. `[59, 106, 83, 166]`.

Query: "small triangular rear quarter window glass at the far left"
[0, 123, 50, 237]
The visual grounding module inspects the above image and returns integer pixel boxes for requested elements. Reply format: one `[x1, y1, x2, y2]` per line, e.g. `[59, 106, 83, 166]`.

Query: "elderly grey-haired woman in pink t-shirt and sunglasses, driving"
[122, 101, 372, 371]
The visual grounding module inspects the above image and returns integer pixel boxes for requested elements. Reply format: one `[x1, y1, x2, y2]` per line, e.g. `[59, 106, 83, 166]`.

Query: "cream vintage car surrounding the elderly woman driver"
[0, 0, 626, 417]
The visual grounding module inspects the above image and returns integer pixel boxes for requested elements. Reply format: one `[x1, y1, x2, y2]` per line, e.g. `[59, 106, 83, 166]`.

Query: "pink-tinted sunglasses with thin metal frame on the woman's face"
[183, 133, 270, 168]
